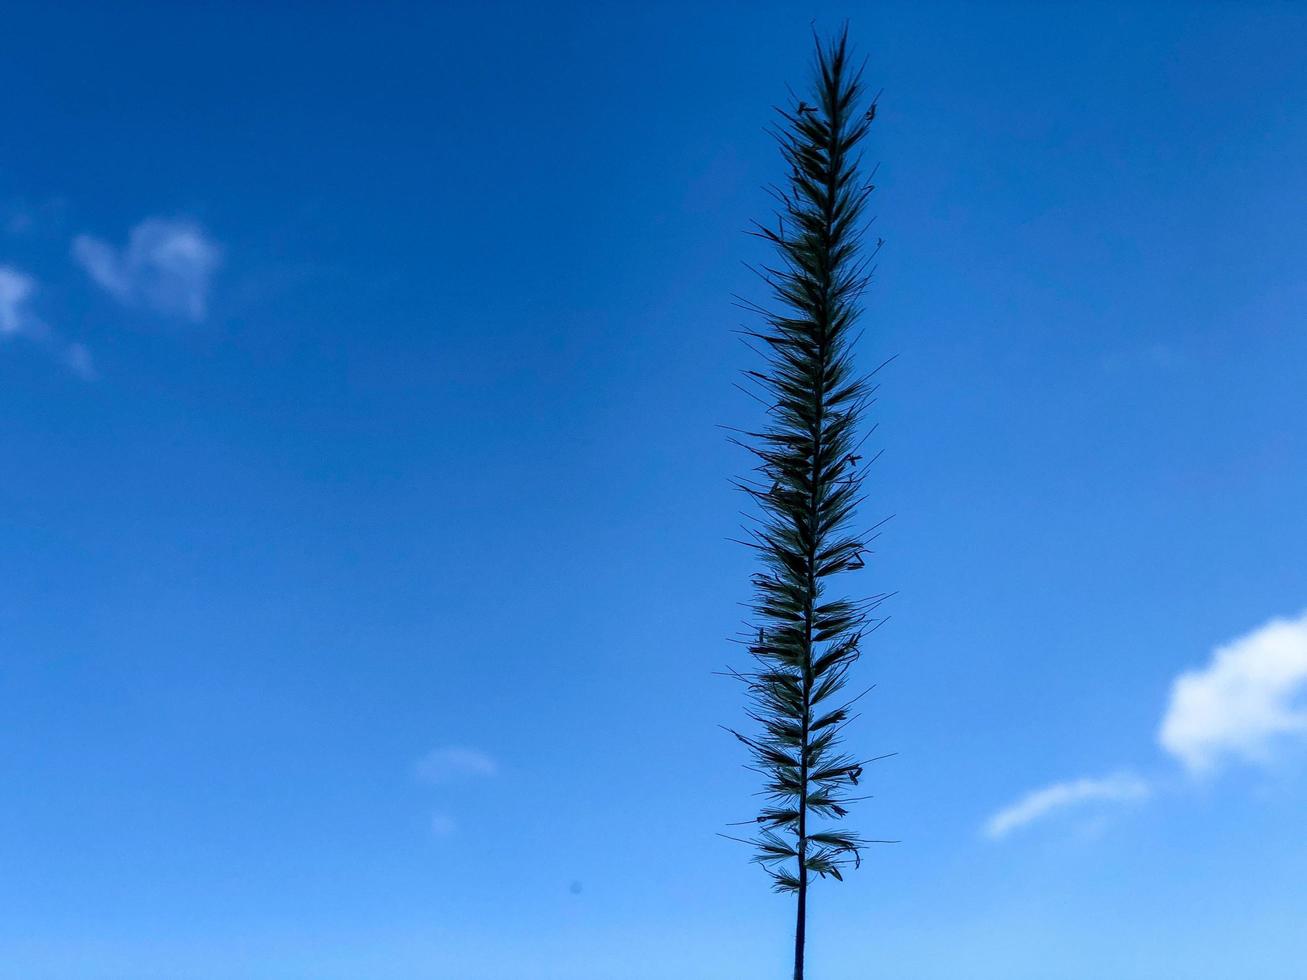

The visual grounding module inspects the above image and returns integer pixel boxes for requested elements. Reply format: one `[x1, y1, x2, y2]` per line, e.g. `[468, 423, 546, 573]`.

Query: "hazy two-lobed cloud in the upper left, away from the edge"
[73, 218, 222, 321]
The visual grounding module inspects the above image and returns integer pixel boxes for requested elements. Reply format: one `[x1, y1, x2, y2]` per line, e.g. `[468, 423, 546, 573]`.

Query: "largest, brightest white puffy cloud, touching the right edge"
[1158, 613, 1307, 774]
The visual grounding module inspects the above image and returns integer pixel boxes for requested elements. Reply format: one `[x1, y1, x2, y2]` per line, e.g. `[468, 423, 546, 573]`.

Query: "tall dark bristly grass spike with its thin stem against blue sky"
[733, 24, 881, 976]
